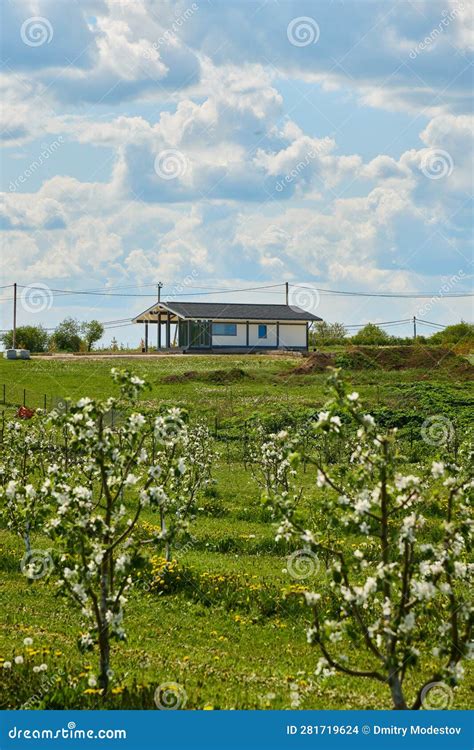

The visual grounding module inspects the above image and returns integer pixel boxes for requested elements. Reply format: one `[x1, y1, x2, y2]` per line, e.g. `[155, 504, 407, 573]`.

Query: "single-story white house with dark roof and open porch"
[133, 301, 321, 352]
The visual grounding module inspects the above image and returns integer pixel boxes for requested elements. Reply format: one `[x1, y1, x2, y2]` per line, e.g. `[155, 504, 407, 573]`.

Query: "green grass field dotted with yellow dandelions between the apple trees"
[0, 356, 474, 709]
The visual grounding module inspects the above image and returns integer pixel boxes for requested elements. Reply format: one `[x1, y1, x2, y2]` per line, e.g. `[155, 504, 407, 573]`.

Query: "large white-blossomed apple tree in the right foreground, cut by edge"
[271, 373, 474, 709]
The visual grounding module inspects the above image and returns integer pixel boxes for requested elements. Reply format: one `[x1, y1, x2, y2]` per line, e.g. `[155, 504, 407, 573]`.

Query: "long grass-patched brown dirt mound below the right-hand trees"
[286, 346, 474, 380]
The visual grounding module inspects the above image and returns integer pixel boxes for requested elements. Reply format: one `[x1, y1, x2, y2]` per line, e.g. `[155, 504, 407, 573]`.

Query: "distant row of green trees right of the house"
[309, 320, 474, 347]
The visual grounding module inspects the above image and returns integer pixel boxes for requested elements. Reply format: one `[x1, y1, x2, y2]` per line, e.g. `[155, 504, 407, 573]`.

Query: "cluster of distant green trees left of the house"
[1, 318, 104, 352]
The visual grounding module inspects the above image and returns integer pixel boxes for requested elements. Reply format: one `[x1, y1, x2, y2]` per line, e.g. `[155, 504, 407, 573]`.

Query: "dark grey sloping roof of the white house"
[163, 301, 321, 321]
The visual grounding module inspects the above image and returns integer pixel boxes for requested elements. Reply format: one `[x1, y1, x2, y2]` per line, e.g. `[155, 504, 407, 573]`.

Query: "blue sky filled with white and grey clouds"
[0, 0, 474, 342]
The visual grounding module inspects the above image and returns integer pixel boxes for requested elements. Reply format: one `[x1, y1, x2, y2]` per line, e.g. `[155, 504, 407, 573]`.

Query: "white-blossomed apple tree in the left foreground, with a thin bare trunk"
[40, 370, 211, 694]
